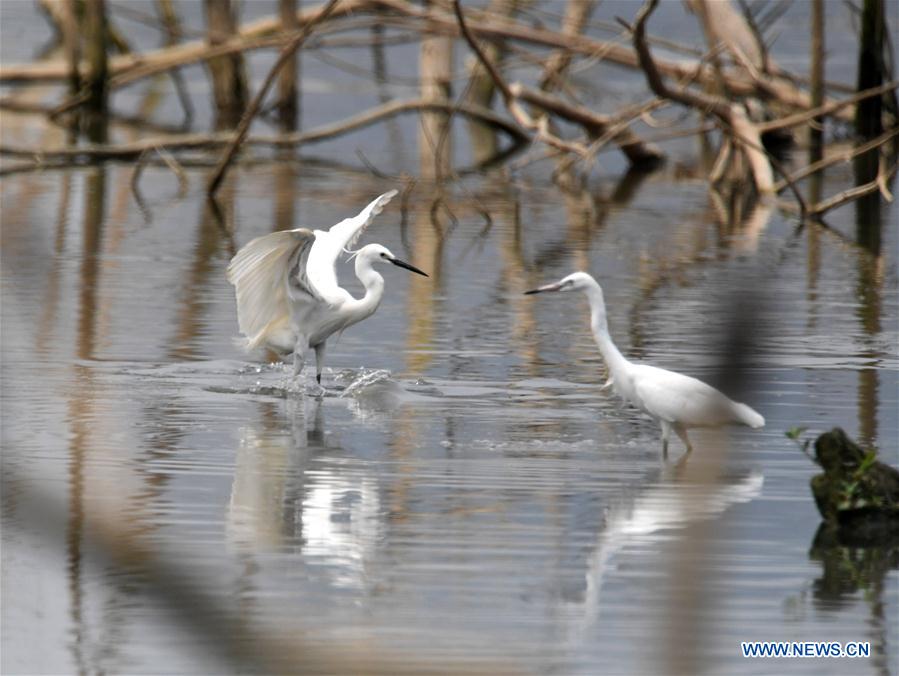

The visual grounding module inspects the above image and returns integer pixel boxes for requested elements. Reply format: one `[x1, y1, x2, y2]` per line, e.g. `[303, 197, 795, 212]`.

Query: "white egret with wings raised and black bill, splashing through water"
[227, 190, 428, 384]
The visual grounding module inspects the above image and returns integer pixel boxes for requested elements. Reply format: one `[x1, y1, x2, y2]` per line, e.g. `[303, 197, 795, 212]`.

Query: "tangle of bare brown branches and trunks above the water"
[0, 0, 897, 216]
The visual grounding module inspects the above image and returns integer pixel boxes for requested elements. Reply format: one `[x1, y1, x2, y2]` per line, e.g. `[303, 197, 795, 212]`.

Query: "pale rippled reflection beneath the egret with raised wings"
[226, 398, 381, 588]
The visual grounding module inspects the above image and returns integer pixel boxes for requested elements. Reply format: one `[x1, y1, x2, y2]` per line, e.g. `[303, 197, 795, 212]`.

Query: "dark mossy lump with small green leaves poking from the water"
[811, 427, 899, 533]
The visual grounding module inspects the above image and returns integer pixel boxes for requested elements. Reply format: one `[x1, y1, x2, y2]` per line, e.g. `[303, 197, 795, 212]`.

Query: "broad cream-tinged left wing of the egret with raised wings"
[227, 228, 321, 349]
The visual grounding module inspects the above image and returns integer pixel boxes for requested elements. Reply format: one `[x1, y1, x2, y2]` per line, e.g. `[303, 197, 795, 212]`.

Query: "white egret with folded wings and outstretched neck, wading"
[525, 272, 765, 457]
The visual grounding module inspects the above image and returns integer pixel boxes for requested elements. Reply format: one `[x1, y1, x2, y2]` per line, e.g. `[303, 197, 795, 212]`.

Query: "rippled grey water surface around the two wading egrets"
[0, 2, 899, 674]
